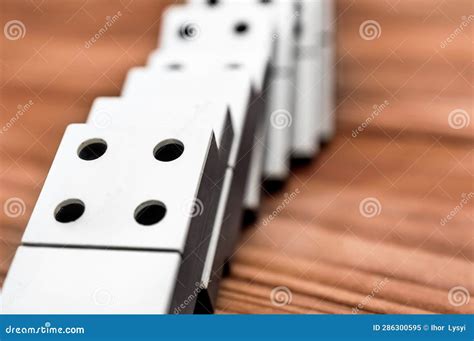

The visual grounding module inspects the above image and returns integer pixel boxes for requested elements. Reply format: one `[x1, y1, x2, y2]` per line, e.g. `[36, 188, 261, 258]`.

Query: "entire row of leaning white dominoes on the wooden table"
[3, 0, 334, 313]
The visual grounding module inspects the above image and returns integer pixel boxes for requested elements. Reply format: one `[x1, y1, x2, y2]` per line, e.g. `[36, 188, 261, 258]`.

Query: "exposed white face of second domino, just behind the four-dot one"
[87, 95, 234, 173]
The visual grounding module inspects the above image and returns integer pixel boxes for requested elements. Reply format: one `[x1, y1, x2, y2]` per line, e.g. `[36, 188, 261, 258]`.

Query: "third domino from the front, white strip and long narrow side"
[118, 67, 258, 310]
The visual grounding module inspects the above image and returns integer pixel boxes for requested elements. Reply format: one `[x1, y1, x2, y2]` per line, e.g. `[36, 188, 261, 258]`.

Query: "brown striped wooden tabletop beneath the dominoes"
[0, 0, 474, 313]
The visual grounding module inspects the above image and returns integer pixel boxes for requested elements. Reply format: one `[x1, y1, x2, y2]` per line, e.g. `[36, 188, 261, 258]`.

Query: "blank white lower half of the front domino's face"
[3, 246, 181, 314]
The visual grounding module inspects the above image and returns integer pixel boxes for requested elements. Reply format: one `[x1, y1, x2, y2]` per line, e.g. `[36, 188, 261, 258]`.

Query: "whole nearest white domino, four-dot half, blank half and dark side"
[3, 102, 226, 313]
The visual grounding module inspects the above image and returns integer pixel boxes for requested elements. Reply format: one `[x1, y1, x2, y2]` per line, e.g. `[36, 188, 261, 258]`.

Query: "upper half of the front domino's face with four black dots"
[23, 125, 219, 253]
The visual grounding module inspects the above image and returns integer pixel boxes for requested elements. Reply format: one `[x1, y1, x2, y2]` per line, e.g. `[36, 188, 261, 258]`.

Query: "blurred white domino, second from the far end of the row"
[189, 0, 298, 182]
